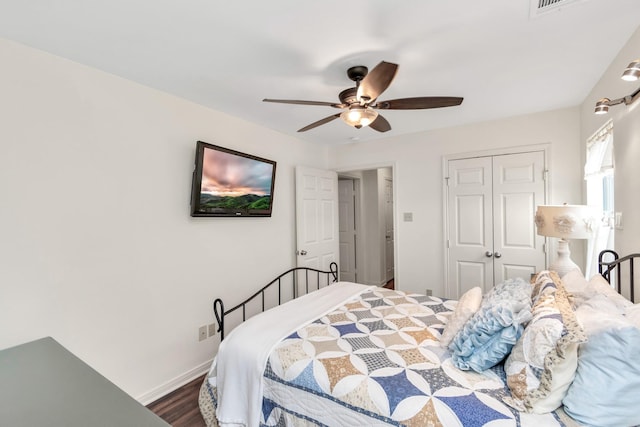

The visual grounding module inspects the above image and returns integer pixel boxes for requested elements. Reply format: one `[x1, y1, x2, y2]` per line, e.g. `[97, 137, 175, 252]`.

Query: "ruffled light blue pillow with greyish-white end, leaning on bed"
[449, 278, 531, 372]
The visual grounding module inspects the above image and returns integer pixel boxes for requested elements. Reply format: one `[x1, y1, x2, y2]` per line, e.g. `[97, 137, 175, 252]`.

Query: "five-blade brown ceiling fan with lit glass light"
[262, 61, 464, 132]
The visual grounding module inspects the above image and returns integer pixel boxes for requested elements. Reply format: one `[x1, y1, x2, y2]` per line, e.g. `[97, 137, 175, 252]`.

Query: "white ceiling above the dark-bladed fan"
[0, 0, 640, 144]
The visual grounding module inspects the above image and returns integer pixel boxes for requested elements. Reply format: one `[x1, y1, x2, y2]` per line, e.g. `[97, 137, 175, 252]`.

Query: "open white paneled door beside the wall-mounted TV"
[296, 166, 339, 270]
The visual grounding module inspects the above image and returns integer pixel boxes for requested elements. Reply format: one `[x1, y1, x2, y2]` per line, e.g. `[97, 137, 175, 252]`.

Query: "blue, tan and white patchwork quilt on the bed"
[207, 288, 565, 427]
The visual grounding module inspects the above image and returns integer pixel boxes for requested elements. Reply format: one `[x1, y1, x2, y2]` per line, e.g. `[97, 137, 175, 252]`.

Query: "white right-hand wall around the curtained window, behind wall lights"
[580, 27, 640, 298]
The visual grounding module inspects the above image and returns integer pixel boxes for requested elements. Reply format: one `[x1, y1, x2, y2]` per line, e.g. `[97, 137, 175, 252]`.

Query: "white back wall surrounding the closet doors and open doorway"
[330, 108, 582, 295]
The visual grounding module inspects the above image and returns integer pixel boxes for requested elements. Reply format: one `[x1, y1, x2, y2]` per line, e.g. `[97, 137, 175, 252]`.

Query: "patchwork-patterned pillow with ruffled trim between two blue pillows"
[504, 271, 586, 414]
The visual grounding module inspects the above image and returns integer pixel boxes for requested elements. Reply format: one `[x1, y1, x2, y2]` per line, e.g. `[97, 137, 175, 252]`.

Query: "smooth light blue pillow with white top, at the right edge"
[562, 306, 640, 427]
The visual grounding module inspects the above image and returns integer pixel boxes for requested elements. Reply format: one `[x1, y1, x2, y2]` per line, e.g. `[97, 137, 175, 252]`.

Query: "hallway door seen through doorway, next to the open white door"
[338, 179, 357, 282]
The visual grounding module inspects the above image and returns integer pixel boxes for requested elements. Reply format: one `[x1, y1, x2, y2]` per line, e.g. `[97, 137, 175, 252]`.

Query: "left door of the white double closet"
[447, 157, 493, 298]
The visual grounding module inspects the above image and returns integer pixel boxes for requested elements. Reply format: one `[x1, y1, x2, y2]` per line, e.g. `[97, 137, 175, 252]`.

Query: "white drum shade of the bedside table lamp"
[536, 205, 596, 239]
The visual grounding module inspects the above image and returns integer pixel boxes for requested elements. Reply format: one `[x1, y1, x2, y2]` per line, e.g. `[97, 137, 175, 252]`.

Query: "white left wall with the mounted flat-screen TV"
[0, 39, 327, 398]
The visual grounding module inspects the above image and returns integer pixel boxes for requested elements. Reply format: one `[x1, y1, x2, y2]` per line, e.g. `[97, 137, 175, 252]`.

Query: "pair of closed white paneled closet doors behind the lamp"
[447, 151, 546, 298]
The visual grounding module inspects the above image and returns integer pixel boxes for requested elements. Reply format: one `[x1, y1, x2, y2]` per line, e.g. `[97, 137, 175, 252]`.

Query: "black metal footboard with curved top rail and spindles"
[213, 262, 338, 341]
